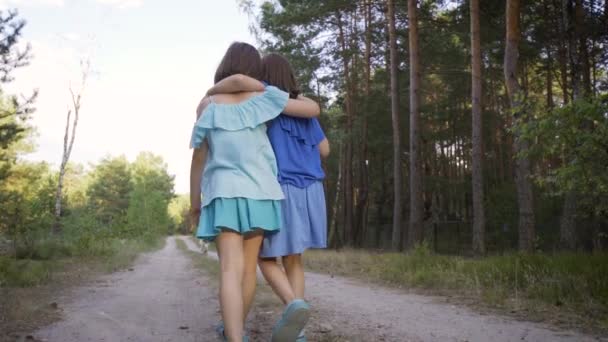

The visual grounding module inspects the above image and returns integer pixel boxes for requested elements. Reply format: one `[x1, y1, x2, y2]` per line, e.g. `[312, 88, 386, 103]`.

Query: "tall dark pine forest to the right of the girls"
[240, 0, 608, 255]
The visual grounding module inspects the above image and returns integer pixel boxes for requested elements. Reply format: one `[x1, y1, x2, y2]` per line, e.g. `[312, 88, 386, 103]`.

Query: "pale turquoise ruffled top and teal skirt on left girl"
[190, 86, 289, 241]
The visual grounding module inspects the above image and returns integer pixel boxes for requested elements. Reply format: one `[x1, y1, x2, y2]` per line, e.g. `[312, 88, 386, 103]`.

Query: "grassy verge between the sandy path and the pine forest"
[304, 246, 608, 330]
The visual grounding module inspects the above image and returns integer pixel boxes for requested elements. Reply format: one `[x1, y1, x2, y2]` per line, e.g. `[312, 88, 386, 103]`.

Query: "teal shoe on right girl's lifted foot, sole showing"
[271, 299, 310, 342]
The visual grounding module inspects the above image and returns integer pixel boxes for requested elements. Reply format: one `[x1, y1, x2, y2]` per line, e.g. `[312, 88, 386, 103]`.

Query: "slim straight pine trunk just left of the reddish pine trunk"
[387, 0, 402, 250]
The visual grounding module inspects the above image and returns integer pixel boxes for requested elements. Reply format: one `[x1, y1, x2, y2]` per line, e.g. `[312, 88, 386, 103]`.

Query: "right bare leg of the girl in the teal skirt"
[243, 230, 264, 323]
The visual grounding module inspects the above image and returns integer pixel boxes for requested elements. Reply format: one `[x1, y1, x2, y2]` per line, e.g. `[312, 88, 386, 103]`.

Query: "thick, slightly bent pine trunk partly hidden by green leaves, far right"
[504, 0, 535, 252]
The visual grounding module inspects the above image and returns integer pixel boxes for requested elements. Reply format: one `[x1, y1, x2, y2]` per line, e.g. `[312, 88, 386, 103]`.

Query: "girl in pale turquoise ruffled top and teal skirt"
[190, 43, 319, 342]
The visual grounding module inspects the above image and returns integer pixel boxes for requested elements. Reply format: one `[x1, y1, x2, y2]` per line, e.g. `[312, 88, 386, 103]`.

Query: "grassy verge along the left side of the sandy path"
[0, 237, 165, 341]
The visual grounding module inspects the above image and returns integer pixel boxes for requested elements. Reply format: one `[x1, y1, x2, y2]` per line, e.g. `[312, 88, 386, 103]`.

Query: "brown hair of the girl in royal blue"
[262, 53, 300, 99]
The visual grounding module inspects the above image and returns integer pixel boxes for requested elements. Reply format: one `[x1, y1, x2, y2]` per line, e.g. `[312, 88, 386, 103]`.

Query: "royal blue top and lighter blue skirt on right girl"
[260, 114, 327, 258]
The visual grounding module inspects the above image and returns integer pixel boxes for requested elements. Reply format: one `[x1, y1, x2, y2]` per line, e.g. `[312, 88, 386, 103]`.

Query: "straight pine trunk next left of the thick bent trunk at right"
[469, 0, 486, 255]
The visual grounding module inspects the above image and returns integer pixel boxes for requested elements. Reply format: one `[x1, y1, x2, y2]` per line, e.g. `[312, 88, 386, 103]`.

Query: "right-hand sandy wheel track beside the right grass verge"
[177, 238, 608, 342]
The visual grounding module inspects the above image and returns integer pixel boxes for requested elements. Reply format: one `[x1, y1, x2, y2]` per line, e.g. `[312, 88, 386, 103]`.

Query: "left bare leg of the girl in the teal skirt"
[217, 230, 244, 342]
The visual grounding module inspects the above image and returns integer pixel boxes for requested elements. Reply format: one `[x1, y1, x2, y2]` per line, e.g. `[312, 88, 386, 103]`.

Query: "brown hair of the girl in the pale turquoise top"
[214, 42, 262, 83]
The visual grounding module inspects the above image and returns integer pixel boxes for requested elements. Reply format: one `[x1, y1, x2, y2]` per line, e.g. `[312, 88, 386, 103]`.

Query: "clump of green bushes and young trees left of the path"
[0, 153, 173, 286]
